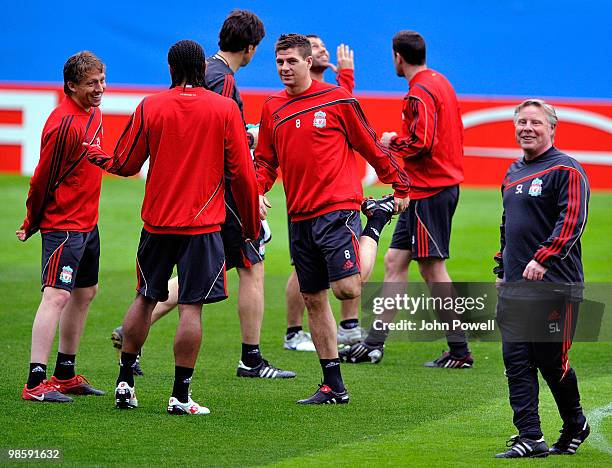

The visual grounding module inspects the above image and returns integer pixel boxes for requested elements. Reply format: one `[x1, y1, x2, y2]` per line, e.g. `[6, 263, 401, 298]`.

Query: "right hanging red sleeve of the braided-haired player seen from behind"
[225, 102, 261, 239]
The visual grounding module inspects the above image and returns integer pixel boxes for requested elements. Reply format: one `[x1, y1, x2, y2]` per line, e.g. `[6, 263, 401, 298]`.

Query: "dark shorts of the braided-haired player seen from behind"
[136, 229, 227, 304]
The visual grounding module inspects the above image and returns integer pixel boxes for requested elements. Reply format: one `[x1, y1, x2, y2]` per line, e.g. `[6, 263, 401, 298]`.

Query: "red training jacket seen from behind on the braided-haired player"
[88, 87, 261, 239]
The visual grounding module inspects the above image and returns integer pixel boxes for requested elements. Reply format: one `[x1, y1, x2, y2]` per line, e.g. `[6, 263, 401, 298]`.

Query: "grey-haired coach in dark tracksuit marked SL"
[494, 100, 589, 458]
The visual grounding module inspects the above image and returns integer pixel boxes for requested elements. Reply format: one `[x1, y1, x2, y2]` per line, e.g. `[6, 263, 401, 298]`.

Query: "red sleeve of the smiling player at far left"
[22, 115, 80, 238]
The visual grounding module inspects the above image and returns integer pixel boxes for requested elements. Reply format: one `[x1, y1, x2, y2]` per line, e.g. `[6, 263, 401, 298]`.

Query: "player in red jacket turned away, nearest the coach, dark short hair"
[342, 31, 474, 369]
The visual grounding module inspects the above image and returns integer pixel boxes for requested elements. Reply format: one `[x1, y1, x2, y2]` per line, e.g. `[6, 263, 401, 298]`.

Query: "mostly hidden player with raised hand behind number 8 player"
[283, 34, 363, 351]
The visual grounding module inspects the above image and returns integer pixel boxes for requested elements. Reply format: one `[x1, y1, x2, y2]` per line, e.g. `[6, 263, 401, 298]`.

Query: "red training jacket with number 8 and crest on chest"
[255, 80, 409, 221]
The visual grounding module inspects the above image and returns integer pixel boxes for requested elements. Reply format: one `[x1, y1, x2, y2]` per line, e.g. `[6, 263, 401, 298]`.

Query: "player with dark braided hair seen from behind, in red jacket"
[88, 41, 261, 414]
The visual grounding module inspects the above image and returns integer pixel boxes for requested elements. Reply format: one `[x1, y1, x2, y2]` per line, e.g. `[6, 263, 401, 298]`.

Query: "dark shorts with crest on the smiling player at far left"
[41, 226, 100, 291]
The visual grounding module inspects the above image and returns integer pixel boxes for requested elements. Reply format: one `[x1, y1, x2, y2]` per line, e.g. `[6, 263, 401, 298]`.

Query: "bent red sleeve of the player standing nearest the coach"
[389, 84, 437, 158]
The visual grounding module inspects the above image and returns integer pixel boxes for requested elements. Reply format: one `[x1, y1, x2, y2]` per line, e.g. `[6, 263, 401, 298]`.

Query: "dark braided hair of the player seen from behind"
[168, 40, 206, 88]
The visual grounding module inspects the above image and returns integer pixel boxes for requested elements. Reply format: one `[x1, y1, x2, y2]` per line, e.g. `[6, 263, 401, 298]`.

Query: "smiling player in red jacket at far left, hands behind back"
[16, 51, 106, 402]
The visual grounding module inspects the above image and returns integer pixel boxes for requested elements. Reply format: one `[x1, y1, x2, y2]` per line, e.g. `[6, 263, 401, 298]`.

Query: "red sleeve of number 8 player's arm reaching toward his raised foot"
[341, 98, 410, 198]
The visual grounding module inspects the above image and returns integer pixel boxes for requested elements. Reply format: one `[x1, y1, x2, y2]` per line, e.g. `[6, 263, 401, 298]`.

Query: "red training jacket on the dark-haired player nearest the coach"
[389, 69, 463, 200]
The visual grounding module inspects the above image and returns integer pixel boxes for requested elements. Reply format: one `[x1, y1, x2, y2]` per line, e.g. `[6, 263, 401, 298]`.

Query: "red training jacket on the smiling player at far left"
[22, 96, 103, 237]
